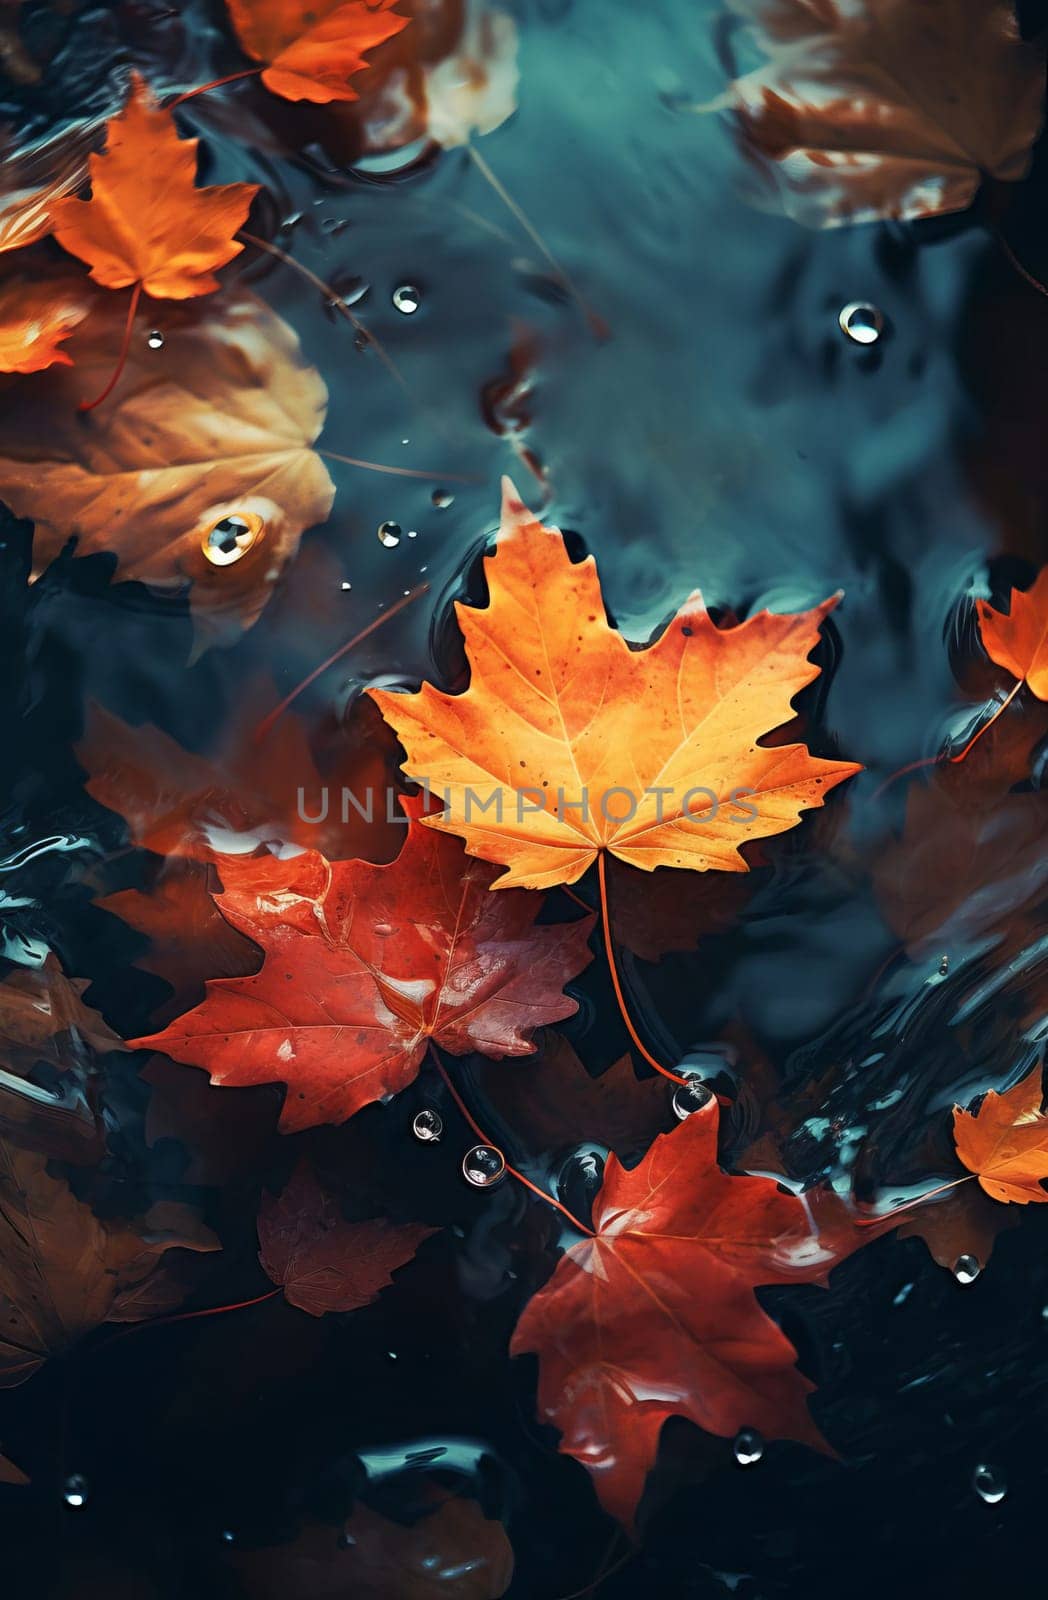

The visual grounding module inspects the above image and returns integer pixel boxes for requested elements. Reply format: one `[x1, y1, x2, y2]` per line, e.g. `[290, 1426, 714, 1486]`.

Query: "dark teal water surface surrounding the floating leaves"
[0, 0, 1048, 1600]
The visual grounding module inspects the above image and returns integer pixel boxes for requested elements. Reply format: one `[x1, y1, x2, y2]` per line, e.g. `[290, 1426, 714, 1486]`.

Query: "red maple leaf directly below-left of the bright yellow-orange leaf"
[131, 800, 592, 1133]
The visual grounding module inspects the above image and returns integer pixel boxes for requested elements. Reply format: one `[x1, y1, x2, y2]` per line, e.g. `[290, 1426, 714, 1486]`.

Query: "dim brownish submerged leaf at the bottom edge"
[234, 1483, 514, 1600]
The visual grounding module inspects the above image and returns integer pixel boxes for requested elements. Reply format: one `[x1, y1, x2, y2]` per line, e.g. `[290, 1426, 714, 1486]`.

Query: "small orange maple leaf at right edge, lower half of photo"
[954, 1066, 1048, 1205]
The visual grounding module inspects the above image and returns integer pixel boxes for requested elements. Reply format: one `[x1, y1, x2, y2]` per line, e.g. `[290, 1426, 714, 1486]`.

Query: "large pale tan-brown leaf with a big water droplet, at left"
[0, 291, 334, 646]
